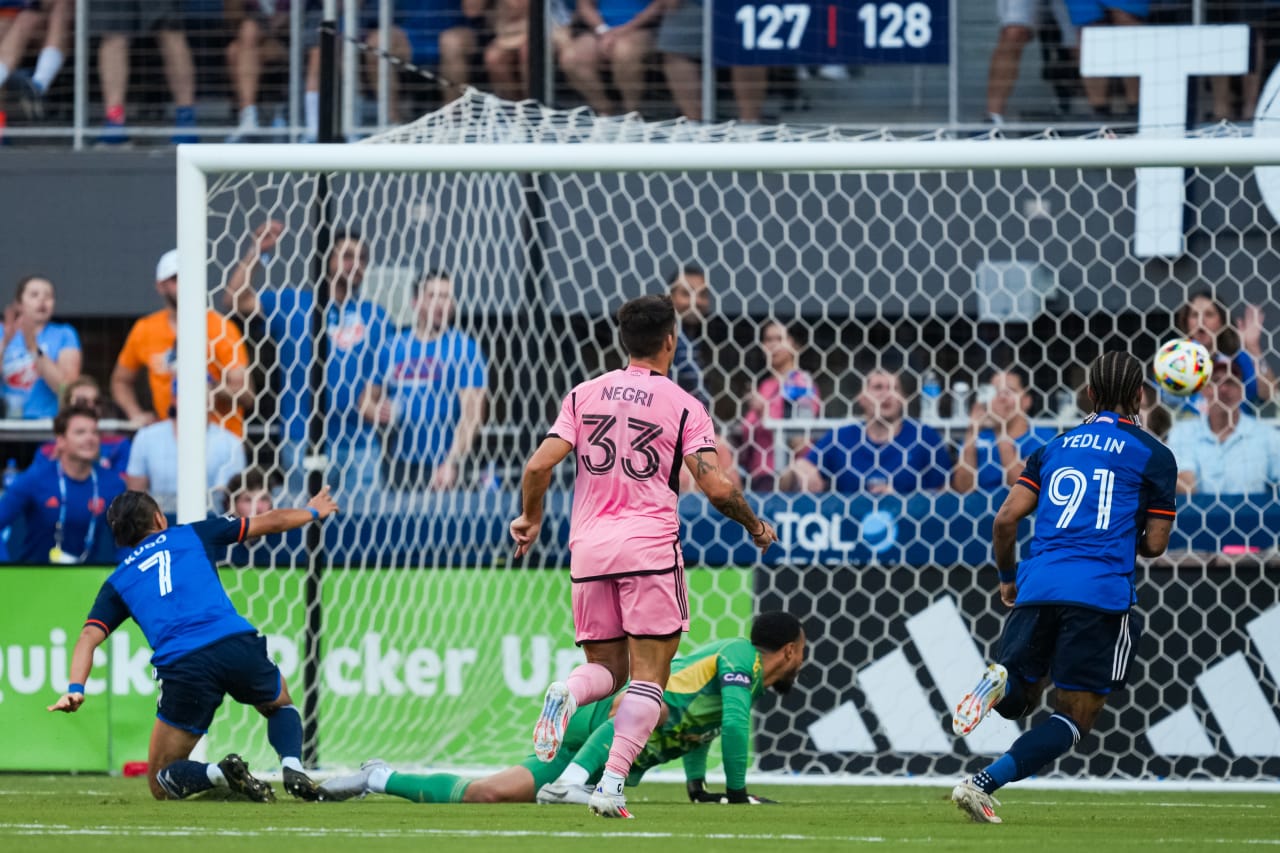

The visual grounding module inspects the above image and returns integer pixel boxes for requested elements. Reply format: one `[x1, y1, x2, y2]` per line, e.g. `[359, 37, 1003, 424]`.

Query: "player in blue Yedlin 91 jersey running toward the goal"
[951, 352, 1178, 824]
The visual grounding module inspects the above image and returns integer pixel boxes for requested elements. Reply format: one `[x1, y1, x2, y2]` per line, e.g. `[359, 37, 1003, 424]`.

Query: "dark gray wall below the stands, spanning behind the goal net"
[0, 150, 1280, 319]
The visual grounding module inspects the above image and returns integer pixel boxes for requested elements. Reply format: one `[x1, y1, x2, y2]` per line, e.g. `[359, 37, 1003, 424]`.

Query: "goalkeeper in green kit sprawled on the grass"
[320, 612, 805, 817]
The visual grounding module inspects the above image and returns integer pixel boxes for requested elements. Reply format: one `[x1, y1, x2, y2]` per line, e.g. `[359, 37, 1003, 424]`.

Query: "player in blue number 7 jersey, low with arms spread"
[49, 488, 338, 803]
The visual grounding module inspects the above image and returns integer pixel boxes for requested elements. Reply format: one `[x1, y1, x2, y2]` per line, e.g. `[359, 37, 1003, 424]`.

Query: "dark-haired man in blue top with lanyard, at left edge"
[0, 406, 124, 565]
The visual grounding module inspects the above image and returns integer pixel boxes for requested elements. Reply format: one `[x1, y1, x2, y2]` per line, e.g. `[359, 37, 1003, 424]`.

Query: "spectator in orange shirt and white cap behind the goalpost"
[111, 250, 253, 438]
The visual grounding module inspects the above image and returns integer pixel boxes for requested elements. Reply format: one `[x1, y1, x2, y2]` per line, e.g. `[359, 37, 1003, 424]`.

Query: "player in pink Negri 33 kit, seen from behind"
[511, 296, 777, 817]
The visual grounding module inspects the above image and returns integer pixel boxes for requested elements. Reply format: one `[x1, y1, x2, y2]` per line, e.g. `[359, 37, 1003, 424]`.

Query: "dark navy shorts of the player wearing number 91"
[997, 605, 1142, 695]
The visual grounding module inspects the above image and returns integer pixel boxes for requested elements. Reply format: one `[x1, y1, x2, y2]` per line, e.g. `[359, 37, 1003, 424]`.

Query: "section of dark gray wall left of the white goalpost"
[0, 149, 178, 316]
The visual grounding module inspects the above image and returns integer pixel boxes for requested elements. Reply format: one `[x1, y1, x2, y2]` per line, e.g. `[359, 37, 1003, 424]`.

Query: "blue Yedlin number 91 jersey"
[1018, 411, 1178, 612]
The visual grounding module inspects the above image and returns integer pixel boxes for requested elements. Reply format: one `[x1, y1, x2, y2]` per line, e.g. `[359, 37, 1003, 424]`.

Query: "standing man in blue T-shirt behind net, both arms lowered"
[360, 272, 488, 489]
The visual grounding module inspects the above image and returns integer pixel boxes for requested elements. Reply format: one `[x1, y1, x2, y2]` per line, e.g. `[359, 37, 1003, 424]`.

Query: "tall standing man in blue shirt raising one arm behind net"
[225, 220, 387, 496]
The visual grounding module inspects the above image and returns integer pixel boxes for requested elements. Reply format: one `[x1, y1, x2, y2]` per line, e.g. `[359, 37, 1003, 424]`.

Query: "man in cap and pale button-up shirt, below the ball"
[1169, 353, 1280, 494]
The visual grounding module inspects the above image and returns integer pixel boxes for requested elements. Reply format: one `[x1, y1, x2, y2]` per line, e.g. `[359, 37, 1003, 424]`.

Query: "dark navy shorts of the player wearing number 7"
[156, 633, 284, 734]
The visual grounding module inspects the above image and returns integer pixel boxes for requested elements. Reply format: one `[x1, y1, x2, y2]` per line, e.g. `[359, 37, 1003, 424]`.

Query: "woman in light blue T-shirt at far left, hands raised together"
[0, 275, 81, 419]
